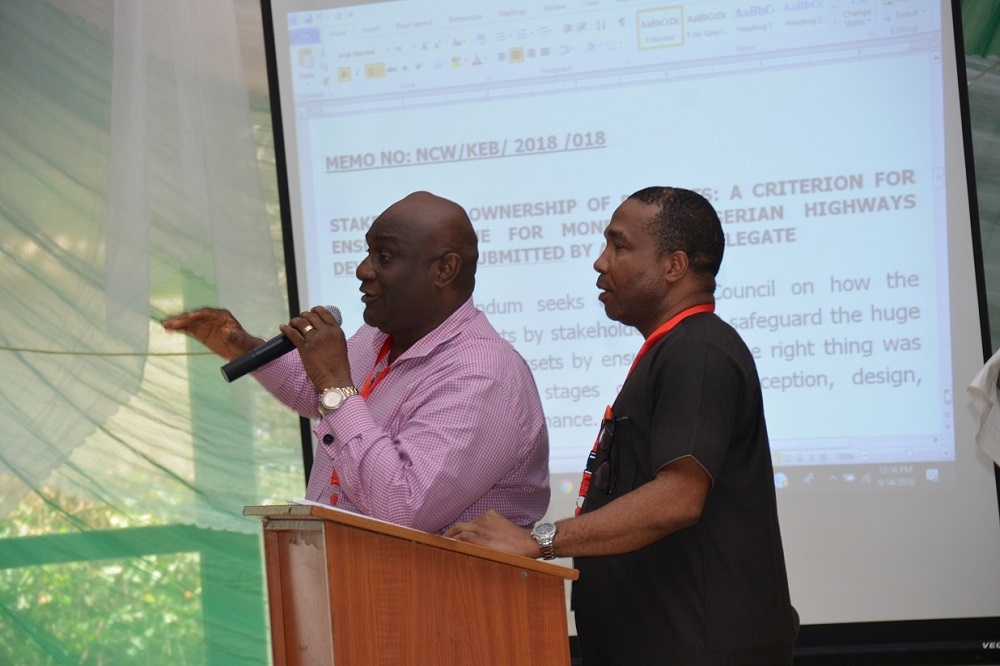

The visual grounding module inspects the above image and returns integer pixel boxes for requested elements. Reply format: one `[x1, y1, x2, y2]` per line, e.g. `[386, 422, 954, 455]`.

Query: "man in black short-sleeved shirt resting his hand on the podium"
[446, 187, 798, 666]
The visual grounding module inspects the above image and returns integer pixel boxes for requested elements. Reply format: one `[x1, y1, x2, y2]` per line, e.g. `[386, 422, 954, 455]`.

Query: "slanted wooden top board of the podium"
[243, 504, 580, 580]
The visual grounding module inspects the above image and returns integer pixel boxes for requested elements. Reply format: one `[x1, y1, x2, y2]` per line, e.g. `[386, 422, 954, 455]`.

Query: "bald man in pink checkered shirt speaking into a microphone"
[163, 192, 549, 532]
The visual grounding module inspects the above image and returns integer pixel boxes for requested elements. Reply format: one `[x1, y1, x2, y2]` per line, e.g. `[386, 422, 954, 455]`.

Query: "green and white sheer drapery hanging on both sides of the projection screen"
[0, 0, 1000, 664]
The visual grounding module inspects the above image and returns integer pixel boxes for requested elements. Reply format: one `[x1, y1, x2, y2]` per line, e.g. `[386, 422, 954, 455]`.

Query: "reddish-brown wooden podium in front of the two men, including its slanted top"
[243, 504, 578, 666]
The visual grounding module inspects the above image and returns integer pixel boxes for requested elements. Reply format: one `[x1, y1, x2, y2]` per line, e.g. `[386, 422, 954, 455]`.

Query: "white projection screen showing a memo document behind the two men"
[262, 0, 1000, 643]
